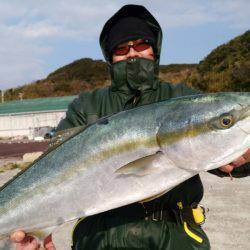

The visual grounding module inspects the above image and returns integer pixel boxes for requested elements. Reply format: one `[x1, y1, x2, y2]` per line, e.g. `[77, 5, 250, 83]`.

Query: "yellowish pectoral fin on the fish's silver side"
[115, 151, 163, 176]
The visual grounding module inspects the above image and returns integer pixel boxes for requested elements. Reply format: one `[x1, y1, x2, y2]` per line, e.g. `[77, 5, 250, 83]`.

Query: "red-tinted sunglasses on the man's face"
[113, 40, 151, 56]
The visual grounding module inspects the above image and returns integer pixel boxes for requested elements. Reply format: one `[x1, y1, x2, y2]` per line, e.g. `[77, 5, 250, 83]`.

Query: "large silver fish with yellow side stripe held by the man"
[0, 93, 250, 237]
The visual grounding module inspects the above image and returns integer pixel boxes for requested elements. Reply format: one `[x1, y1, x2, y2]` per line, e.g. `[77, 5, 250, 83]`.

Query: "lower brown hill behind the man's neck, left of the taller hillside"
[2, 58, 196, 100]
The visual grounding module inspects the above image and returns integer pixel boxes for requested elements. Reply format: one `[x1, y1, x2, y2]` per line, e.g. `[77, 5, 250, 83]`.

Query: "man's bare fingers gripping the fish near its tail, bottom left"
[10, 231, 56, 250]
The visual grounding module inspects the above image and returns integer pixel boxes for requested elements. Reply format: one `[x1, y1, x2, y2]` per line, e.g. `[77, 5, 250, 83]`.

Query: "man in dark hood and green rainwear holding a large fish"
[12, 5, 250, 250]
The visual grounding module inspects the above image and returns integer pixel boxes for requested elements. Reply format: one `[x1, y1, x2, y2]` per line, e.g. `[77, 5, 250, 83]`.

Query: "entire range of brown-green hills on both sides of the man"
[2, 31, 250, 100]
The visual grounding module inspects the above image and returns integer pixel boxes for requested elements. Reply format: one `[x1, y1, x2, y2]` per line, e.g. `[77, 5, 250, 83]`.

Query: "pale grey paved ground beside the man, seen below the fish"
[0, 159, 250, 250]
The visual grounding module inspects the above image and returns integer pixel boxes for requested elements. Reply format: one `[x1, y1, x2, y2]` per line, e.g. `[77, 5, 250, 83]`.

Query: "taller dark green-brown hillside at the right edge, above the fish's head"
[188, 31, 250, 92]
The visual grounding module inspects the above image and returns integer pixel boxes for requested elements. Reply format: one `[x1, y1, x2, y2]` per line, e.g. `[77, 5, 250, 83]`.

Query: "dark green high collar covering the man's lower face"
[111, 57, 158, 92]
